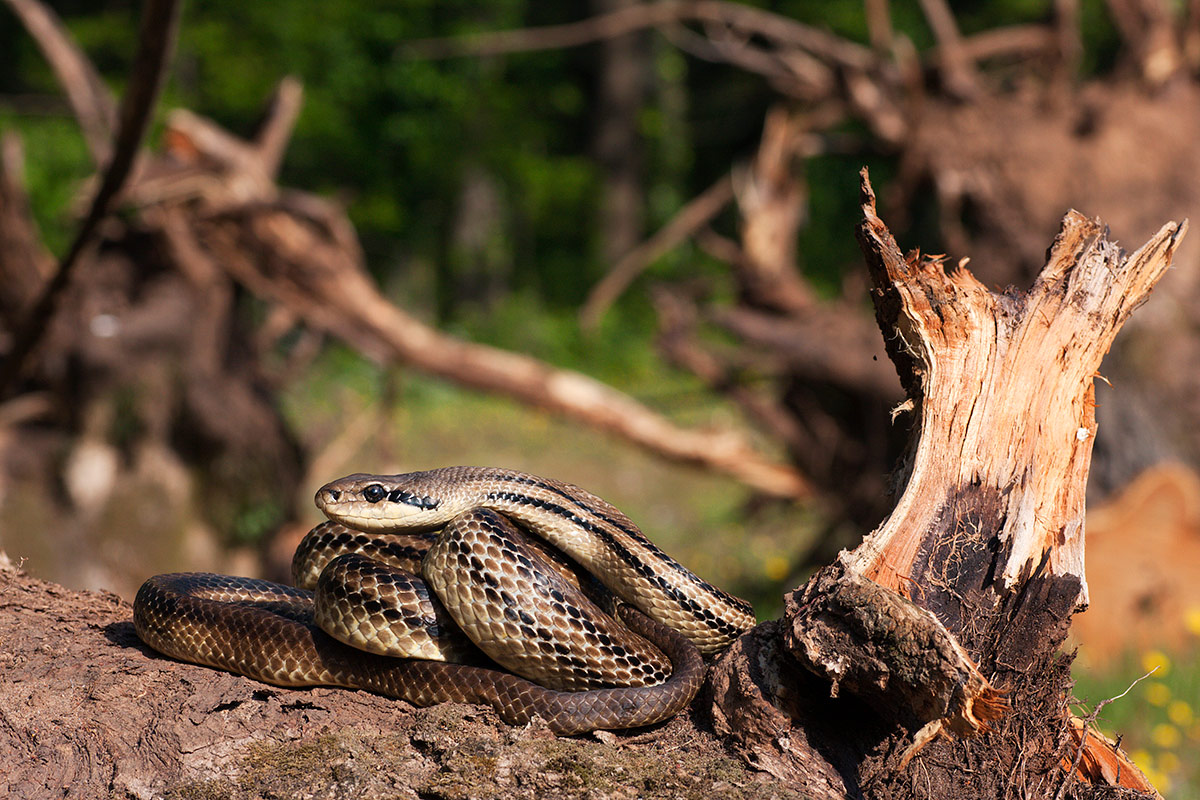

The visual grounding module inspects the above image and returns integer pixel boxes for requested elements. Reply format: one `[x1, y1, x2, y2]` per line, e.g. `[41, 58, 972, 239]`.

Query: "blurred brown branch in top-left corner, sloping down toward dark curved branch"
[7, 0, 116, 169]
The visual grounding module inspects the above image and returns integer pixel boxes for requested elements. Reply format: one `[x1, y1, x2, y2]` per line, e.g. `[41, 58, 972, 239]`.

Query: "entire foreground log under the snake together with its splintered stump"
[0, 173, 1171, 798]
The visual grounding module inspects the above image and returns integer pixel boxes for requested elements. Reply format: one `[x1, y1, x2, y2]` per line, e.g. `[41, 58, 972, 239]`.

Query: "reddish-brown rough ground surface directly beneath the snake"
[0, 553, 805, 800]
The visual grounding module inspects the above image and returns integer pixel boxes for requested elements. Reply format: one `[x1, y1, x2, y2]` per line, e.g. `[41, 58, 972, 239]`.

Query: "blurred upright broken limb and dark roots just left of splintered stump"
[604, 103, 899, 532]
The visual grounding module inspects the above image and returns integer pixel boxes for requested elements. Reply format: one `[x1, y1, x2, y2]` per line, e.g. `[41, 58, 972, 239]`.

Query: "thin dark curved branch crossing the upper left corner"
[0, 0, 180, 397]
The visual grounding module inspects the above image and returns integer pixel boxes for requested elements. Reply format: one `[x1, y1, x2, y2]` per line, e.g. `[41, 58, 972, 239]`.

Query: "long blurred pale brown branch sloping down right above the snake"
[199, 205, 810, 497]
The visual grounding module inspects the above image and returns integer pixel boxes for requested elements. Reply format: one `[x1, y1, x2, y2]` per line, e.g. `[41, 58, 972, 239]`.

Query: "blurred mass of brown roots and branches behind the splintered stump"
[398, 0, 1200, 537]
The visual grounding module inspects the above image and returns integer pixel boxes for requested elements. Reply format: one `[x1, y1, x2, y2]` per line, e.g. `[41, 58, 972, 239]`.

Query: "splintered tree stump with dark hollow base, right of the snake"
[713, 170, 1187, 798]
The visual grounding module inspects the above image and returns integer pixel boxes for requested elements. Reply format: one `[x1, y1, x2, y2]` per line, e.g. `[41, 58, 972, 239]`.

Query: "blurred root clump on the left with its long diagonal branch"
[4, 0, 811, 594]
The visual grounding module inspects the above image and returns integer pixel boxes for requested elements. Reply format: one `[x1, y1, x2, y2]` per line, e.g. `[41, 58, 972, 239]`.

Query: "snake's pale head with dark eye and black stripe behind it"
[316, 474, 454, 530]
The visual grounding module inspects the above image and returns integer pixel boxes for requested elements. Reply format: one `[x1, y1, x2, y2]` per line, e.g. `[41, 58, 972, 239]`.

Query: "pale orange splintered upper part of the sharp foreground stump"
[846, 187, 1187, 604]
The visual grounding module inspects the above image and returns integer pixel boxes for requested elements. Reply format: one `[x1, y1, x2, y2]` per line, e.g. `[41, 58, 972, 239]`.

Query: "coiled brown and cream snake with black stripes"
[133, 467, 755, 735]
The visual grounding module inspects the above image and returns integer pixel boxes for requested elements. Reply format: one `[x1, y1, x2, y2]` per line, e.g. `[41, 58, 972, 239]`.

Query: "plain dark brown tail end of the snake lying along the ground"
[133, 573, 704, 735]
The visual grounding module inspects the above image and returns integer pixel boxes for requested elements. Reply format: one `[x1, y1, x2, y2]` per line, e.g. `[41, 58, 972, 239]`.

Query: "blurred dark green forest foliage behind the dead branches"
[0, 0, 1115, 345]
